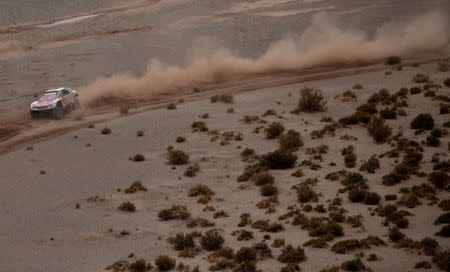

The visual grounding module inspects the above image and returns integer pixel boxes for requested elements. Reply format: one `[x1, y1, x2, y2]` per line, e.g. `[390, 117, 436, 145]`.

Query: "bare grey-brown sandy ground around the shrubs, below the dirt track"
[0, 60, 450, 271]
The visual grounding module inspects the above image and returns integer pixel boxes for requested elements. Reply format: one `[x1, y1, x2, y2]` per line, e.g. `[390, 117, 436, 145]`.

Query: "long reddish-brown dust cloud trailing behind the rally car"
[81, 12, 449, 107]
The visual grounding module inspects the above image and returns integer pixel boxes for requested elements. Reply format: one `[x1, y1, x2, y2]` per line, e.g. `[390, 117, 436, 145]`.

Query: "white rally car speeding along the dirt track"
[30, 87, 80, 119]
